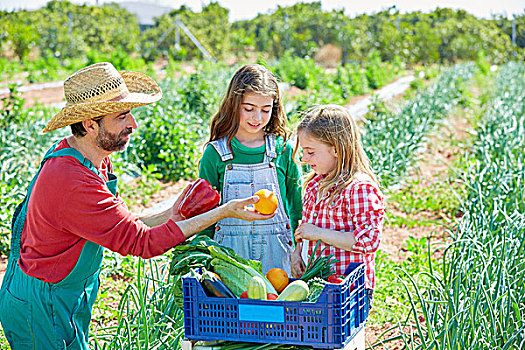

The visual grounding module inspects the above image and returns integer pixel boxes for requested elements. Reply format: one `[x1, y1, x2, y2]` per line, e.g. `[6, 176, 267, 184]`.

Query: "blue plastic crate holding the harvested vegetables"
[182, 263, 368, 349]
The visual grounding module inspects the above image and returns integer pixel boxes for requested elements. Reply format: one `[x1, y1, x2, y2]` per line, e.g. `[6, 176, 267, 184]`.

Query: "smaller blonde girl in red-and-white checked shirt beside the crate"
[292, 105, 384, 297]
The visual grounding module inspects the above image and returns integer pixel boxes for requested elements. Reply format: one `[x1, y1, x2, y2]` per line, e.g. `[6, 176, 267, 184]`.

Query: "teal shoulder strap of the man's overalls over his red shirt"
[9, 141, 105, 261]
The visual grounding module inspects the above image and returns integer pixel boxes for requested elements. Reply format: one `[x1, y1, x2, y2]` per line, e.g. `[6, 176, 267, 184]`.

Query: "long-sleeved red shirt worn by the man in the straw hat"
[19, 139, 185, 283]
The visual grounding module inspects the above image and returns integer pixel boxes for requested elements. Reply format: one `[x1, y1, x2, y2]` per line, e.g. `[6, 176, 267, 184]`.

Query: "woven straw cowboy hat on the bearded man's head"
[43, 62, 162, 132]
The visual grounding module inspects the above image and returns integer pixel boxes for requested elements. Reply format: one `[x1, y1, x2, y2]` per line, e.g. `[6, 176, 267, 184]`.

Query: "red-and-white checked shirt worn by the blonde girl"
[303, 175, 385, 289]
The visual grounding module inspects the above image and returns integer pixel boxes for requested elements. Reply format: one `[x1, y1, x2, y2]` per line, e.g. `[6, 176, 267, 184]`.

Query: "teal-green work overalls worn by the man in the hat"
[0, 144, 117, 350]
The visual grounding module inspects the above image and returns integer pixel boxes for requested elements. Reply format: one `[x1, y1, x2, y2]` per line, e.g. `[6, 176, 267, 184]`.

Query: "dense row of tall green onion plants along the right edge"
[388, 62, 525, 349]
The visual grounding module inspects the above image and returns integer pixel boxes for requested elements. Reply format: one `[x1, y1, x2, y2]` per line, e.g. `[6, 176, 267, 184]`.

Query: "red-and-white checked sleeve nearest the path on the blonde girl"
[345, 182, 384, 254]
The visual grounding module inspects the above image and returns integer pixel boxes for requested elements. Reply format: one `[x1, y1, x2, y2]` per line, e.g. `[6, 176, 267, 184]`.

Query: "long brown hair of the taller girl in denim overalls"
[206, 64, 288, 149]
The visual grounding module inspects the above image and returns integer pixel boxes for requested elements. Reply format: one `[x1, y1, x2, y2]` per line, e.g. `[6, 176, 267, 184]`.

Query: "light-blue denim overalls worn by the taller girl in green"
[211, 135, 292, 276]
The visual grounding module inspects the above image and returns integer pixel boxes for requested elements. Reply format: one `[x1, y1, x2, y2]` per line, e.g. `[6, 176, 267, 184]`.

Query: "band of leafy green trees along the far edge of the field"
[0, 1, 525, 75]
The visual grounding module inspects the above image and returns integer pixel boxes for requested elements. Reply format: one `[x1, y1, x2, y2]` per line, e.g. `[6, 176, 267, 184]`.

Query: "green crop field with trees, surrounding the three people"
[0, 1, 525, 350]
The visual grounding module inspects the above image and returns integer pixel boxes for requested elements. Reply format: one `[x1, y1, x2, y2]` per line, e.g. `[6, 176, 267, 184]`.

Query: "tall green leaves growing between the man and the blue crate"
[92, 254, 184, 350]
